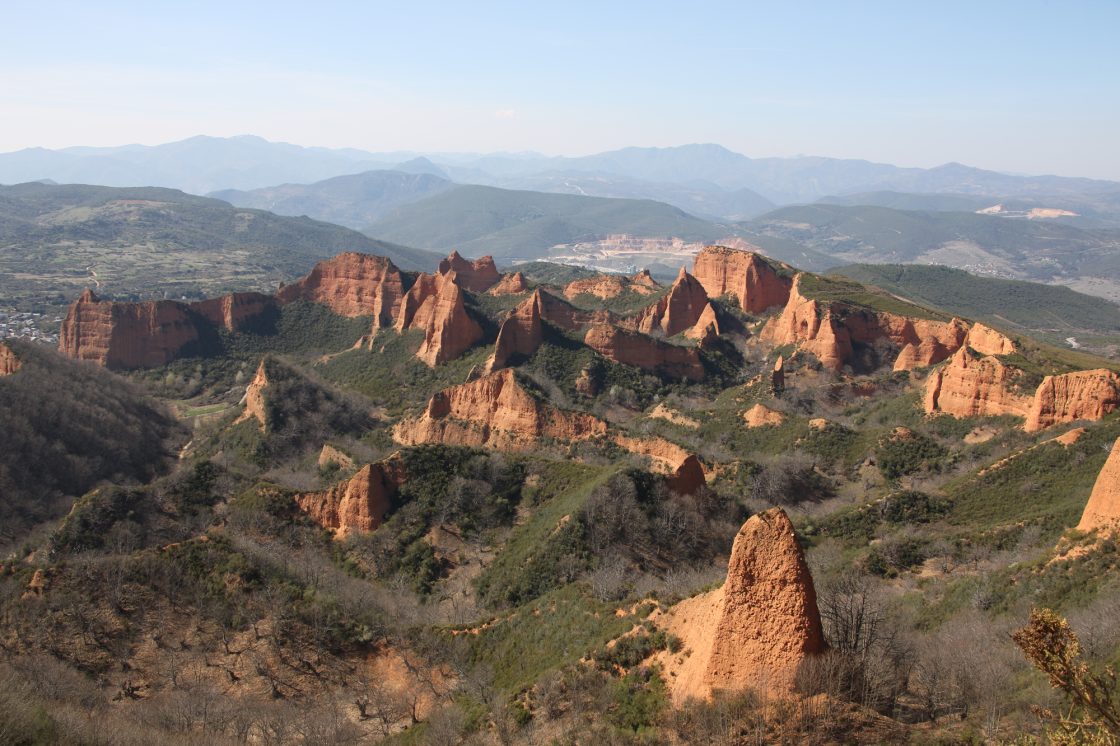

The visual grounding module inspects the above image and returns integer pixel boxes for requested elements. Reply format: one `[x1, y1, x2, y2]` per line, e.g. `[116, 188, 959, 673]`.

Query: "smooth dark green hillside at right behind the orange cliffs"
[829, 264, 1120, 345]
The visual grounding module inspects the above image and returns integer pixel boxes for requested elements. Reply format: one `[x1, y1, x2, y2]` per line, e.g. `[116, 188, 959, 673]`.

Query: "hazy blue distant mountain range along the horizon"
[0, 136, 1120, 220]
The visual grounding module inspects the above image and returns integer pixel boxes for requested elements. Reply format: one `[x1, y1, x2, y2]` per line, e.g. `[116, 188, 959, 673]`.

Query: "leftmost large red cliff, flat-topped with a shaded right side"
[58, 290, 199, 369]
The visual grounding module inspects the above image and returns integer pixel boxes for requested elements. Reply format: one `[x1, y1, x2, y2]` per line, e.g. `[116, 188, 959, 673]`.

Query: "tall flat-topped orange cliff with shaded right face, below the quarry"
[692, 246, 792, 314]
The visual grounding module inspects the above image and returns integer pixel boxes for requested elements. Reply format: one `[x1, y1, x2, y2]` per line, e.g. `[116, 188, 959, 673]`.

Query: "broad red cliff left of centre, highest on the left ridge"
[277, 251, 404, 328]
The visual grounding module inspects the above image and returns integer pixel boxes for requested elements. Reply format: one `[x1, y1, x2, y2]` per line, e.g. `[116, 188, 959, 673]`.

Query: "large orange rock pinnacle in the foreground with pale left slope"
[656, 507, 825, 703]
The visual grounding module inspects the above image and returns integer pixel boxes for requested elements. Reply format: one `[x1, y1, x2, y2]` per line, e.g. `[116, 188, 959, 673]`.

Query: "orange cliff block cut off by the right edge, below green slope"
[1023, 369, 1120, 432]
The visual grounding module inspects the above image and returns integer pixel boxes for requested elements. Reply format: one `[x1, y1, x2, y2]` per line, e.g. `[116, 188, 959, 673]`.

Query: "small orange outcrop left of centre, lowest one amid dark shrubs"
[296, 456, 404, 539]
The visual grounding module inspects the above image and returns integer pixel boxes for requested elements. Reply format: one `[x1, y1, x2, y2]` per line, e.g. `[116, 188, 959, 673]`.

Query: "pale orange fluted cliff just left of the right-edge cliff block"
[923, 347, 1030, 417]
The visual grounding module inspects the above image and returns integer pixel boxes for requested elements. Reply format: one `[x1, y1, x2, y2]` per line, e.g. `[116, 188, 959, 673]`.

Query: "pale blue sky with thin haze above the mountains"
[0, 0, 1120, 180]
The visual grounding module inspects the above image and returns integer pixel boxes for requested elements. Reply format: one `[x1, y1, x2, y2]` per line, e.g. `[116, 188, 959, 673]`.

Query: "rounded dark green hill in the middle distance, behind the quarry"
[365, 186, 727, 259]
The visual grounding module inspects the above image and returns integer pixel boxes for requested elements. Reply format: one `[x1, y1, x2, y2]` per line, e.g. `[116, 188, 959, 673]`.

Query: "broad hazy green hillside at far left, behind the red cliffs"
[0, 183, 438, 304]
